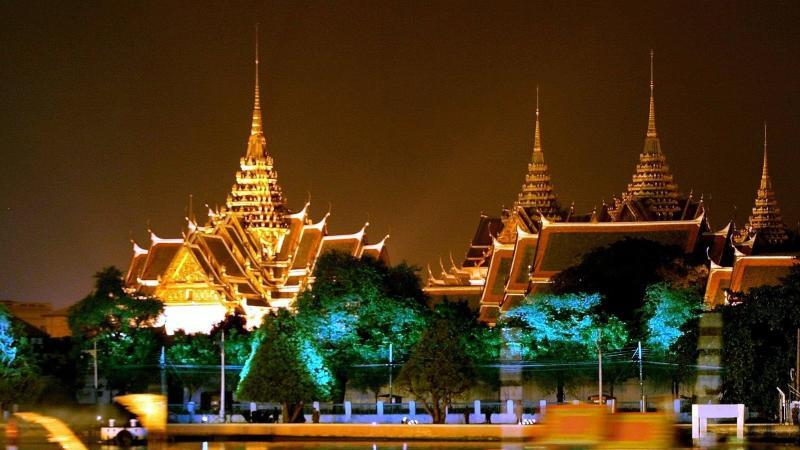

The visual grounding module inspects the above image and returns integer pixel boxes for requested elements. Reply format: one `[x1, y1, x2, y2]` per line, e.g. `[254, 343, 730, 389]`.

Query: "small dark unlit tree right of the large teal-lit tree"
[398, 308, 476, 423]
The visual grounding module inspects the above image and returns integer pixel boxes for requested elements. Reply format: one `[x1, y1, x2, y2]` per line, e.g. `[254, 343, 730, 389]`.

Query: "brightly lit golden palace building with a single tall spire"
[125, 50, 388, 333]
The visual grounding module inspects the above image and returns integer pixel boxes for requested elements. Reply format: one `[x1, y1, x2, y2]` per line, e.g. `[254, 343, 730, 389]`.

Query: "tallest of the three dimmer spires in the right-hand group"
[614, 49, 681, 220]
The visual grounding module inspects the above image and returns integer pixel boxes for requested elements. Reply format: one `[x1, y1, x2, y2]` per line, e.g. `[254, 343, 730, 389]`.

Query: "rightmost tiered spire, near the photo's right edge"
[746, 122, 788, 245]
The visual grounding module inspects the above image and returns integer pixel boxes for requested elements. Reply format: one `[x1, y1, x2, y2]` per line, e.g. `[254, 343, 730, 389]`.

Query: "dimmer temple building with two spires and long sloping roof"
[425, 53, 712, 323]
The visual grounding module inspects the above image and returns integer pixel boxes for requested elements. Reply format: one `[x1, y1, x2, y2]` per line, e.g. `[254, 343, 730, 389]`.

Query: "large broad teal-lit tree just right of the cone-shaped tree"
[297, 252, 427, 400]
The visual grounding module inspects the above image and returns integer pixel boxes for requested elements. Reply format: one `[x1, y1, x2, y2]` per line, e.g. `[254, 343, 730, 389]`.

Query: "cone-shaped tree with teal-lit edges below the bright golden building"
[236, 310, 333, 422]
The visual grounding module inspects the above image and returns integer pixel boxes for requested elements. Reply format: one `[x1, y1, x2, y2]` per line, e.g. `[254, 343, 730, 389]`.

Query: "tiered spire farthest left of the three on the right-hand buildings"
[516, 86, 561, 221]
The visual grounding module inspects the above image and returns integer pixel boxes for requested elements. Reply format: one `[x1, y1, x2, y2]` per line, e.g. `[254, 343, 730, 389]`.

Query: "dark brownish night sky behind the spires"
[0, 0, 800, 305]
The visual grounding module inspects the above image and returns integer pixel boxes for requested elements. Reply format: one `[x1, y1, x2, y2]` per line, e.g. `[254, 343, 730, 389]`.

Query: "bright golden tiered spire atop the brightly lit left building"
[226, 25, 289, 257]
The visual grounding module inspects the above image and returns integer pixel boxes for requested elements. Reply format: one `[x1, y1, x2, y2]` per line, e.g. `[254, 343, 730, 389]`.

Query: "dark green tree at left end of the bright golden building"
[68, 267, 164, 391]
